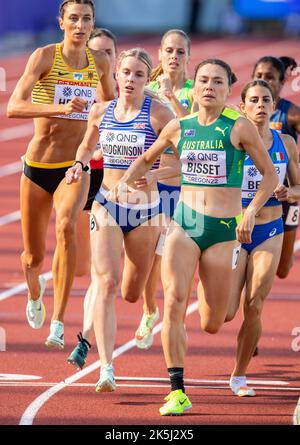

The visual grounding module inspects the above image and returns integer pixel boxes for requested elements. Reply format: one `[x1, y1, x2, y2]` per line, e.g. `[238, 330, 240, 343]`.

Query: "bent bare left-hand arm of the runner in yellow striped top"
[7, 45, 86, 118]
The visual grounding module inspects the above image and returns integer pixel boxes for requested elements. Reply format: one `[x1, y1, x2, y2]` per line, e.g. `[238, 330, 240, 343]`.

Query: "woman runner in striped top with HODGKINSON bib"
[66, 48, 173, 392]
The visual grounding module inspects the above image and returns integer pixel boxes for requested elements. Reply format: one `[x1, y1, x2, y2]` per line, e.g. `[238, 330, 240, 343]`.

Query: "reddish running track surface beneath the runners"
[0, 37, 300, 425]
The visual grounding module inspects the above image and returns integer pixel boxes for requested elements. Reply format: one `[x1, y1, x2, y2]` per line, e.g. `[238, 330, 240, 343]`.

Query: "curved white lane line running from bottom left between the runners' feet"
[20, 301, 198, 425]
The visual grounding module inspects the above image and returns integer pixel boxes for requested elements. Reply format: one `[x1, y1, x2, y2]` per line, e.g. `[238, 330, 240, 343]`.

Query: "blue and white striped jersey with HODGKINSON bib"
[99, 96, 159, 170]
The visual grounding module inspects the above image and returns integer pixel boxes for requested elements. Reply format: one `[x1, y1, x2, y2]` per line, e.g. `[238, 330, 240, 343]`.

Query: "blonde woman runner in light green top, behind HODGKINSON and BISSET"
[135, 29, 193, 349]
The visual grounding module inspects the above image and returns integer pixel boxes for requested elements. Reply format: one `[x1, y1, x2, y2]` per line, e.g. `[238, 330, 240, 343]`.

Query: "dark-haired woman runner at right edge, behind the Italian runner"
[252, 56, 300, 278]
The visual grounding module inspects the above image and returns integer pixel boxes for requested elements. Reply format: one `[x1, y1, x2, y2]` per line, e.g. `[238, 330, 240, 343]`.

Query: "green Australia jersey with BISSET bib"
[178, 108, 245, 188]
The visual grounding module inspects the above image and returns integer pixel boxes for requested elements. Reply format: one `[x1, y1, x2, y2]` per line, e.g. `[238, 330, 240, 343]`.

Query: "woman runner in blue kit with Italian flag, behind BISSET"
[226, 80, 300, 396]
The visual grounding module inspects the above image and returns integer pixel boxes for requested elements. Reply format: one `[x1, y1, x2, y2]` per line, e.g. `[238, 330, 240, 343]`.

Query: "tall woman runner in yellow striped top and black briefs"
[7, 0, 114, 348]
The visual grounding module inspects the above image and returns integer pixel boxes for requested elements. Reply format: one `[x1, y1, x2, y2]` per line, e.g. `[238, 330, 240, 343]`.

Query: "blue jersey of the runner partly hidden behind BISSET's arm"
[242, 126, 289, 207]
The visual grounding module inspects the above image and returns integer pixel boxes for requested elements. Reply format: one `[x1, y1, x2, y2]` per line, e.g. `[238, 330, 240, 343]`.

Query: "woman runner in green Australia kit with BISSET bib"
[111, 59, 278, 416]
